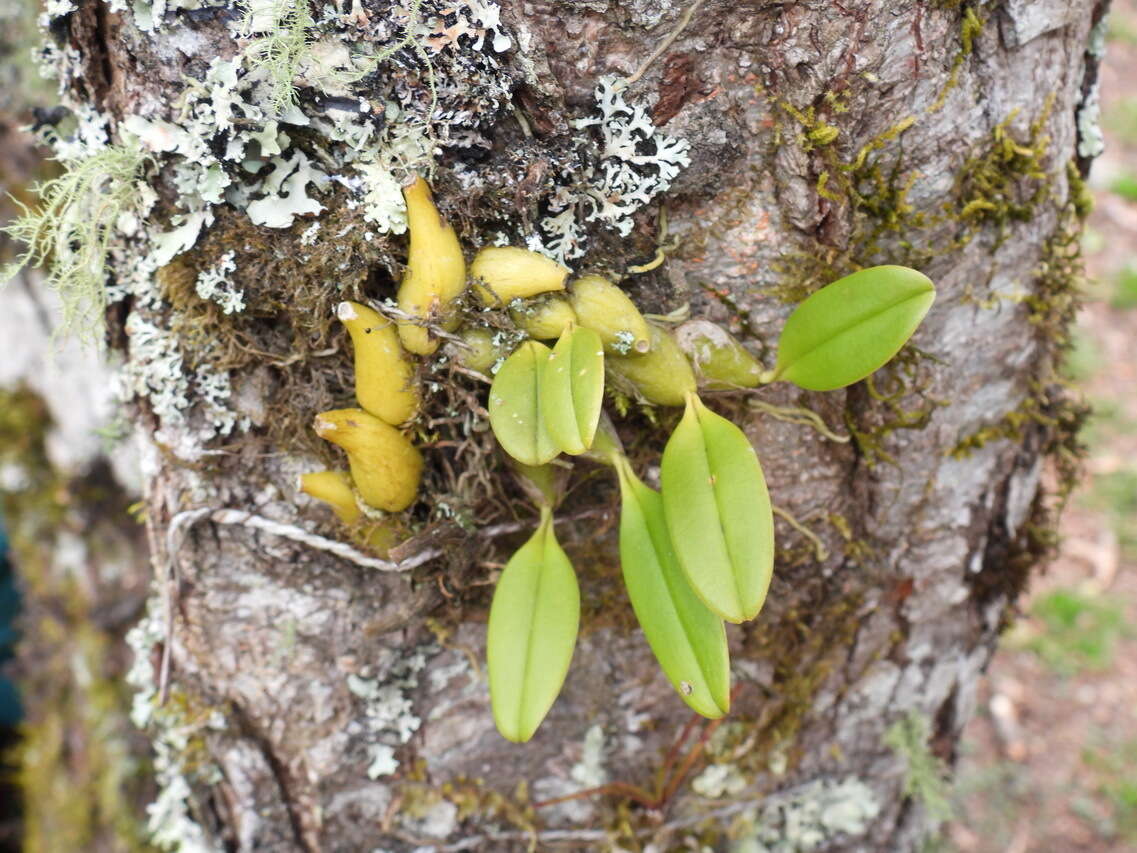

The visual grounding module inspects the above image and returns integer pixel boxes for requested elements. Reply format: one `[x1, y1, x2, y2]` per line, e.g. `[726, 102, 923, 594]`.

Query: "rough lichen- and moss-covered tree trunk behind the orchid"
[6, 0, 1105, 851]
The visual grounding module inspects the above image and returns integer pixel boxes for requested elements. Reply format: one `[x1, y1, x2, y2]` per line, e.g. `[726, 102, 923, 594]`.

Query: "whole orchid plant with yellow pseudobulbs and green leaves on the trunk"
[301, 179, 935, 742]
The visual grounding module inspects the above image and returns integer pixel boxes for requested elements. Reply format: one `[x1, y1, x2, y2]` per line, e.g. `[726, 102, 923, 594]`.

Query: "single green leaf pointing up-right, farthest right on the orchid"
[767, 266, 936, 391]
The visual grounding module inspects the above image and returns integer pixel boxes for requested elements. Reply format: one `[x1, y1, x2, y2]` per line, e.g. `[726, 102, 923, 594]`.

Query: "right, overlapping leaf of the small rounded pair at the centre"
[540, 326, 604, 456]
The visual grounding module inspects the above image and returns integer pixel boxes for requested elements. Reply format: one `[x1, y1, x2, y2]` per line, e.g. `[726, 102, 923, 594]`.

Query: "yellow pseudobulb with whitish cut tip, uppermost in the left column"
[335, 303, 418, 425]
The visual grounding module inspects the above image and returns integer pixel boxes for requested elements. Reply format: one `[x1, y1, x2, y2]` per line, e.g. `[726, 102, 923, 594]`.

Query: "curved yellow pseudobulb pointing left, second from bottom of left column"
[313, 408, 423, 513]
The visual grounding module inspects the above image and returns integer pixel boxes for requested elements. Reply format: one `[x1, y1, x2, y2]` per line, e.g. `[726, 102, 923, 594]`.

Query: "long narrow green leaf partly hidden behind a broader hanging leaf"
[616, 456, 730, 719]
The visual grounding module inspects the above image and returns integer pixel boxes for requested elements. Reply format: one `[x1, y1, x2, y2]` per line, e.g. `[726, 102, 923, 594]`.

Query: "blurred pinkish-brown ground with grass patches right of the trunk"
[940, 0, 1137, 853]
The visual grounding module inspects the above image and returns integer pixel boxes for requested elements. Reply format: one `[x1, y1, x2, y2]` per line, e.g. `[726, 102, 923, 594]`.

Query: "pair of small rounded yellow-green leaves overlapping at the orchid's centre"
[489, 325, 604, 465]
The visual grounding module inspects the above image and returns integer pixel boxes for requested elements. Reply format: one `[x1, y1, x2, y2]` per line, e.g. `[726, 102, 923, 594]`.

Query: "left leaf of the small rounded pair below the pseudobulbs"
[489, 340, 558, 465]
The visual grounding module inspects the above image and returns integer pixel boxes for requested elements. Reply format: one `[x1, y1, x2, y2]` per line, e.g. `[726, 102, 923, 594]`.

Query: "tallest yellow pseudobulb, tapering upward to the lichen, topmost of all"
[398, 177, 466, 355]
